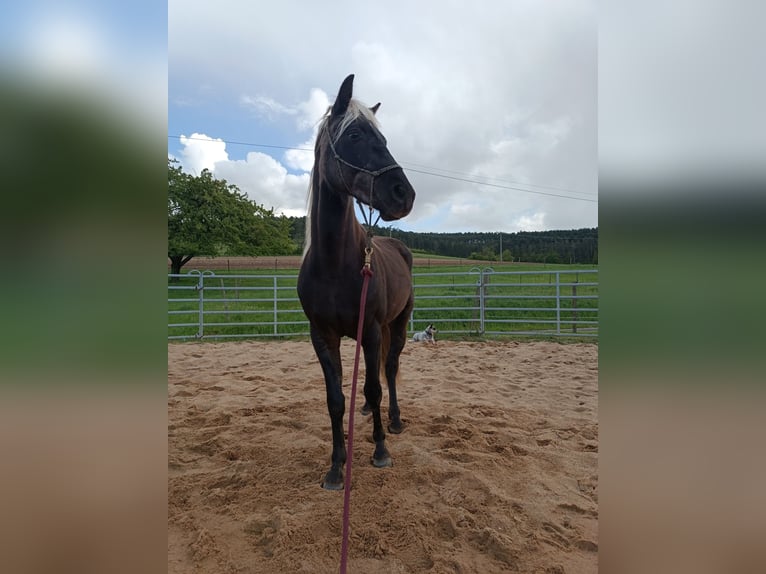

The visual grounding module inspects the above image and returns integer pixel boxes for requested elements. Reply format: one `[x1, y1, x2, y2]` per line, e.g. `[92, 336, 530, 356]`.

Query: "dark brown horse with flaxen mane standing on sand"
[298, 74, 415, 490]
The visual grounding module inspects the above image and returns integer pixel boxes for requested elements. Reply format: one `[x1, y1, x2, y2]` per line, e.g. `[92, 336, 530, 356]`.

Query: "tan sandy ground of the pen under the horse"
[168, 340, 598, 574]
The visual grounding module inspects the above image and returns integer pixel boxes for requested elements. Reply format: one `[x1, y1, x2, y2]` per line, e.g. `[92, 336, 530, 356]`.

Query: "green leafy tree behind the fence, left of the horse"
[168, 160, 295, 273]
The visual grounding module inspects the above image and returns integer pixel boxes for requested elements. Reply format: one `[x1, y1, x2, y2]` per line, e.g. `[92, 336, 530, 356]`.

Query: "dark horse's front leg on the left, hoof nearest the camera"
[311, 329, 346, 490]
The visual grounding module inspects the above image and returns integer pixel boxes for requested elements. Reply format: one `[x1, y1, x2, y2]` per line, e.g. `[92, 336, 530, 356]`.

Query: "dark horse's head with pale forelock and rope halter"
[317, 74, 415, 221]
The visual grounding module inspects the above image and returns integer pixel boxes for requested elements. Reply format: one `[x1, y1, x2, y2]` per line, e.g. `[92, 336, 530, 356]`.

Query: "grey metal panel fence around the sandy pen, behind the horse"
[168, 267, 598, 340]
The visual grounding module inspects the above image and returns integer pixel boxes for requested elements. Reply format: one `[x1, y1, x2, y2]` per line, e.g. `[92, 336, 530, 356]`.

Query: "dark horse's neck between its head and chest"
[311, 182, 365, 267]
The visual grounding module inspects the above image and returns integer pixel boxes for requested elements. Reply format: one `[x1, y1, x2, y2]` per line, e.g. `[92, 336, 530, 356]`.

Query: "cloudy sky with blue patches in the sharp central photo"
[168, 0, 598, 232]
